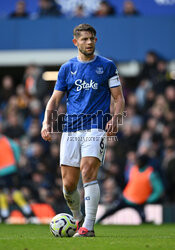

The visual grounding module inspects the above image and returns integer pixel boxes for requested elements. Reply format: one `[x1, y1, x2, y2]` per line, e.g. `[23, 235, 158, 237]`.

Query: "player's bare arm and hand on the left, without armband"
[41, 90, 64, 141]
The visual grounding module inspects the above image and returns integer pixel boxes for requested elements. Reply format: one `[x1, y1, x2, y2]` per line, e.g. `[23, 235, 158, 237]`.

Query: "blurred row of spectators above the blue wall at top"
[5, 0, 139, 19]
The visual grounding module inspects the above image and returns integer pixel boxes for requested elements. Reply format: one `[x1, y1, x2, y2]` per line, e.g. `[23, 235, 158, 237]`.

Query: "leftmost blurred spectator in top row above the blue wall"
[10, 0, 29, 18]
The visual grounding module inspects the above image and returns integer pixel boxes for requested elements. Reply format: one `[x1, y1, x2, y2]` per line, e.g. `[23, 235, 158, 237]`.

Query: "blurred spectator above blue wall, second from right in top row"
[94, 1, 116, 17]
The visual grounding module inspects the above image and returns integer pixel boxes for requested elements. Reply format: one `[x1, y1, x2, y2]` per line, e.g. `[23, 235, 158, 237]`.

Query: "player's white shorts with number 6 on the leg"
[60, 129, 106, 167]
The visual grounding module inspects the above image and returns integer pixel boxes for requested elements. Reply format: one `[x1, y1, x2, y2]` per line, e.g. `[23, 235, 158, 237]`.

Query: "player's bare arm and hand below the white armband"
[106, 86, 125, 136]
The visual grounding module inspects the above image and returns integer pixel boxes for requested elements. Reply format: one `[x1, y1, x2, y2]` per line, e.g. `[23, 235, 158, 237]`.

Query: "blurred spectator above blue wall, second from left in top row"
[38, 0, 61, 17]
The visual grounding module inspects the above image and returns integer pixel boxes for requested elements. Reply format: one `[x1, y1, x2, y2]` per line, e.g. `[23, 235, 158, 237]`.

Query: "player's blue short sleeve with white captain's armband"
[108, 62, 121, 88]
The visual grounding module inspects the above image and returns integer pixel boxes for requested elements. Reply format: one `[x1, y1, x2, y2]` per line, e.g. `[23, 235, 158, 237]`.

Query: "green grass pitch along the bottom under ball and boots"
[0, 224, 175, 250]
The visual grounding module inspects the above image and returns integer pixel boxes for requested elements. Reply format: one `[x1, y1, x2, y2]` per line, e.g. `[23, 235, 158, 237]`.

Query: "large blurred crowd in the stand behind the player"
[0, 51, 175, 221]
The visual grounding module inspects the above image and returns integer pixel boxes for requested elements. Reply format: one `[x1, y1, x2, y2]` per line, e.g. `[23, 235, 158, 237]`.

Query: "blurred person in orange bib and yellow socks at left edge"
[0, 134, 33, 221]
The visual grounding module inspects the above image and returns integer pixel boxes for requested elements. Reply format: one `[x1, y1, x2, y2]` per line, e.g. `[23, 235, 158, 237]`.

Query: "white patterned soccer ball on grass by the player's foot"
[50, 213, 77, 237]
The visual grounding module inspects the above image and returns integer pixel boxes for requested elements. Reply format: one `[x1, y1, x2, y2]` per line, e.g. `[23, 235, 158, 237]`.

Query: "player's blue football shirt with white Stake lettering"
[55, 56, 120, 132]
